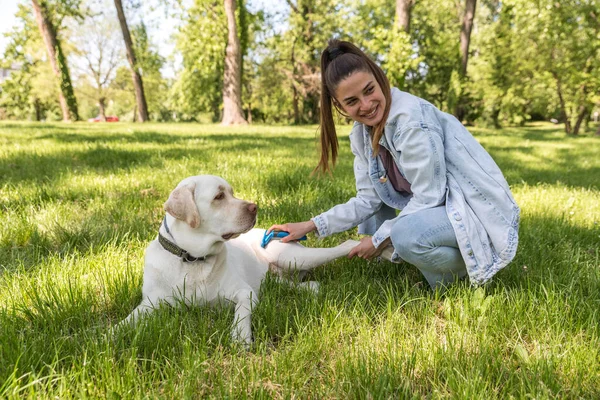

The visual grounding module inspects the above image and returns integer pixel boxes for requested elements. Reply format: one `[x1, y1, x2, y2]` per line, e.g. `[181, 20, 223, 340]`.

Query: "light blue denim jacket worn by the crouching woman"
[312, 88, 520, 284]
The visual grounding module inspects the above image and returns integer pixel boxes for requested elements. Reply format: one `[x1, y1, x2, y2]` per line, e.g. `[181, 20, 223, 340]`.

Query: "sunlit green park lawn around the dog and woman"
[0, 123, 600, 399]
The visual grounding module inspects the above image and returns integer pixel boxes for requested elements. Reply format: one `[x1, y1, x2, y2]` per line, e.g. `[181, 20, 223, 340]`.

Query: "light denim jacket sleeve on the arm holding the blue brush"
[311, 126, 382, 237]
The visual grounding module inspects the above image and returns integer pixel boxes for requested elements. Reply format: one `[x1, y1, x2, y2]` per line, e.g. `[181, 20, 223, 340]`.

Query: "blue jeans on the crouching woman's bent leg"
[390, 206, 467, 288]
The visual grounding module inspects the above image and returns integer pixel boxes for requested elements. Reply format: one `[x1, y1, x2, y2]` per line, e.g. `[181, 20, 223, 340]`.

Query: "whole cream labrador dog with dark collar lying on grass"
[120, 175, 359, 344]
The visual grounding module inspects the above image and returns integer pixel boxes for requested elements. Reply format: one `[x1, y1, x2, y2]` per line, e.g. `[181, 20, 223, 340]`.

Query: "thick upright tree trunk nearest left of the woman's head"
[221, 0, 248, 125]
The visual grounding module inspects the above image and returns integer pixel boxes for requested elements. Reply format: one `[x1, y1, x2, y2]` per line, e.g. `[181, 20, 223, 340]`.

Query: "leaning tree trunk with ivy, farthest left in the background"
[31, 0, 79, 121]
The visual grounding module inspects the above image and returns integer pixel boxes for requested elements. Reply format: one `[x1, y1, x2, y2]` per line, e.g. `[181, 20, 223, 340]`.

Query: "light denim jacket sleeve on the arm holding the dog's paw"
[373, 122, 446, 247]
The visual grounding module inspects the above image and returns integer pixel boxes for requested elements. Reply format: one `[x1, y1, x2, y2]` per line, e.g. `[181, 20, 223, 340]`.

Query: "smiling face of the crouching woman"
[335, 71, 386, 126]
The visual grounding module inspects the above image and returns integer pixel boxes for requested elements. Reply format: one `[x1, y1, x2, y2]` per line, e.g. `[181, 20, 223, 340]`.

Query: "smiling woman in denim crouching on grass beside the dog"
[269, 40, 519, 288]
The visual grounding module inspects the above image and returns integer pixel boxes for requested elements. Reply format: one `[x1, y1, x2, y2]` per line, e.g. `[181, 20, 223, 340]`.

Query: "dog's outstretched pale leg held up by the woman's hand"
[266, 240, 360, 271]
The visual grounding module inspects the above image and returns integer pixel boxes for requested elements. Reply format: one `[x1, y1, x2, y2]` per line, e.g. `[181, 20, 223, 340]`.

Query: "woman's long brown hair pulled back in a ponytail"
[315, 39, 392, 173]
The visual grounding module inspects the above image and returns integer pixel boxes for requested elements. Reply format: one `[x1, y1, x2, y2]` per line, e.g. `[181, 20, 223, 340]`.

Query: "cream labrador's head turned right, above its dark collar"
[165, 175, 257, 240]
